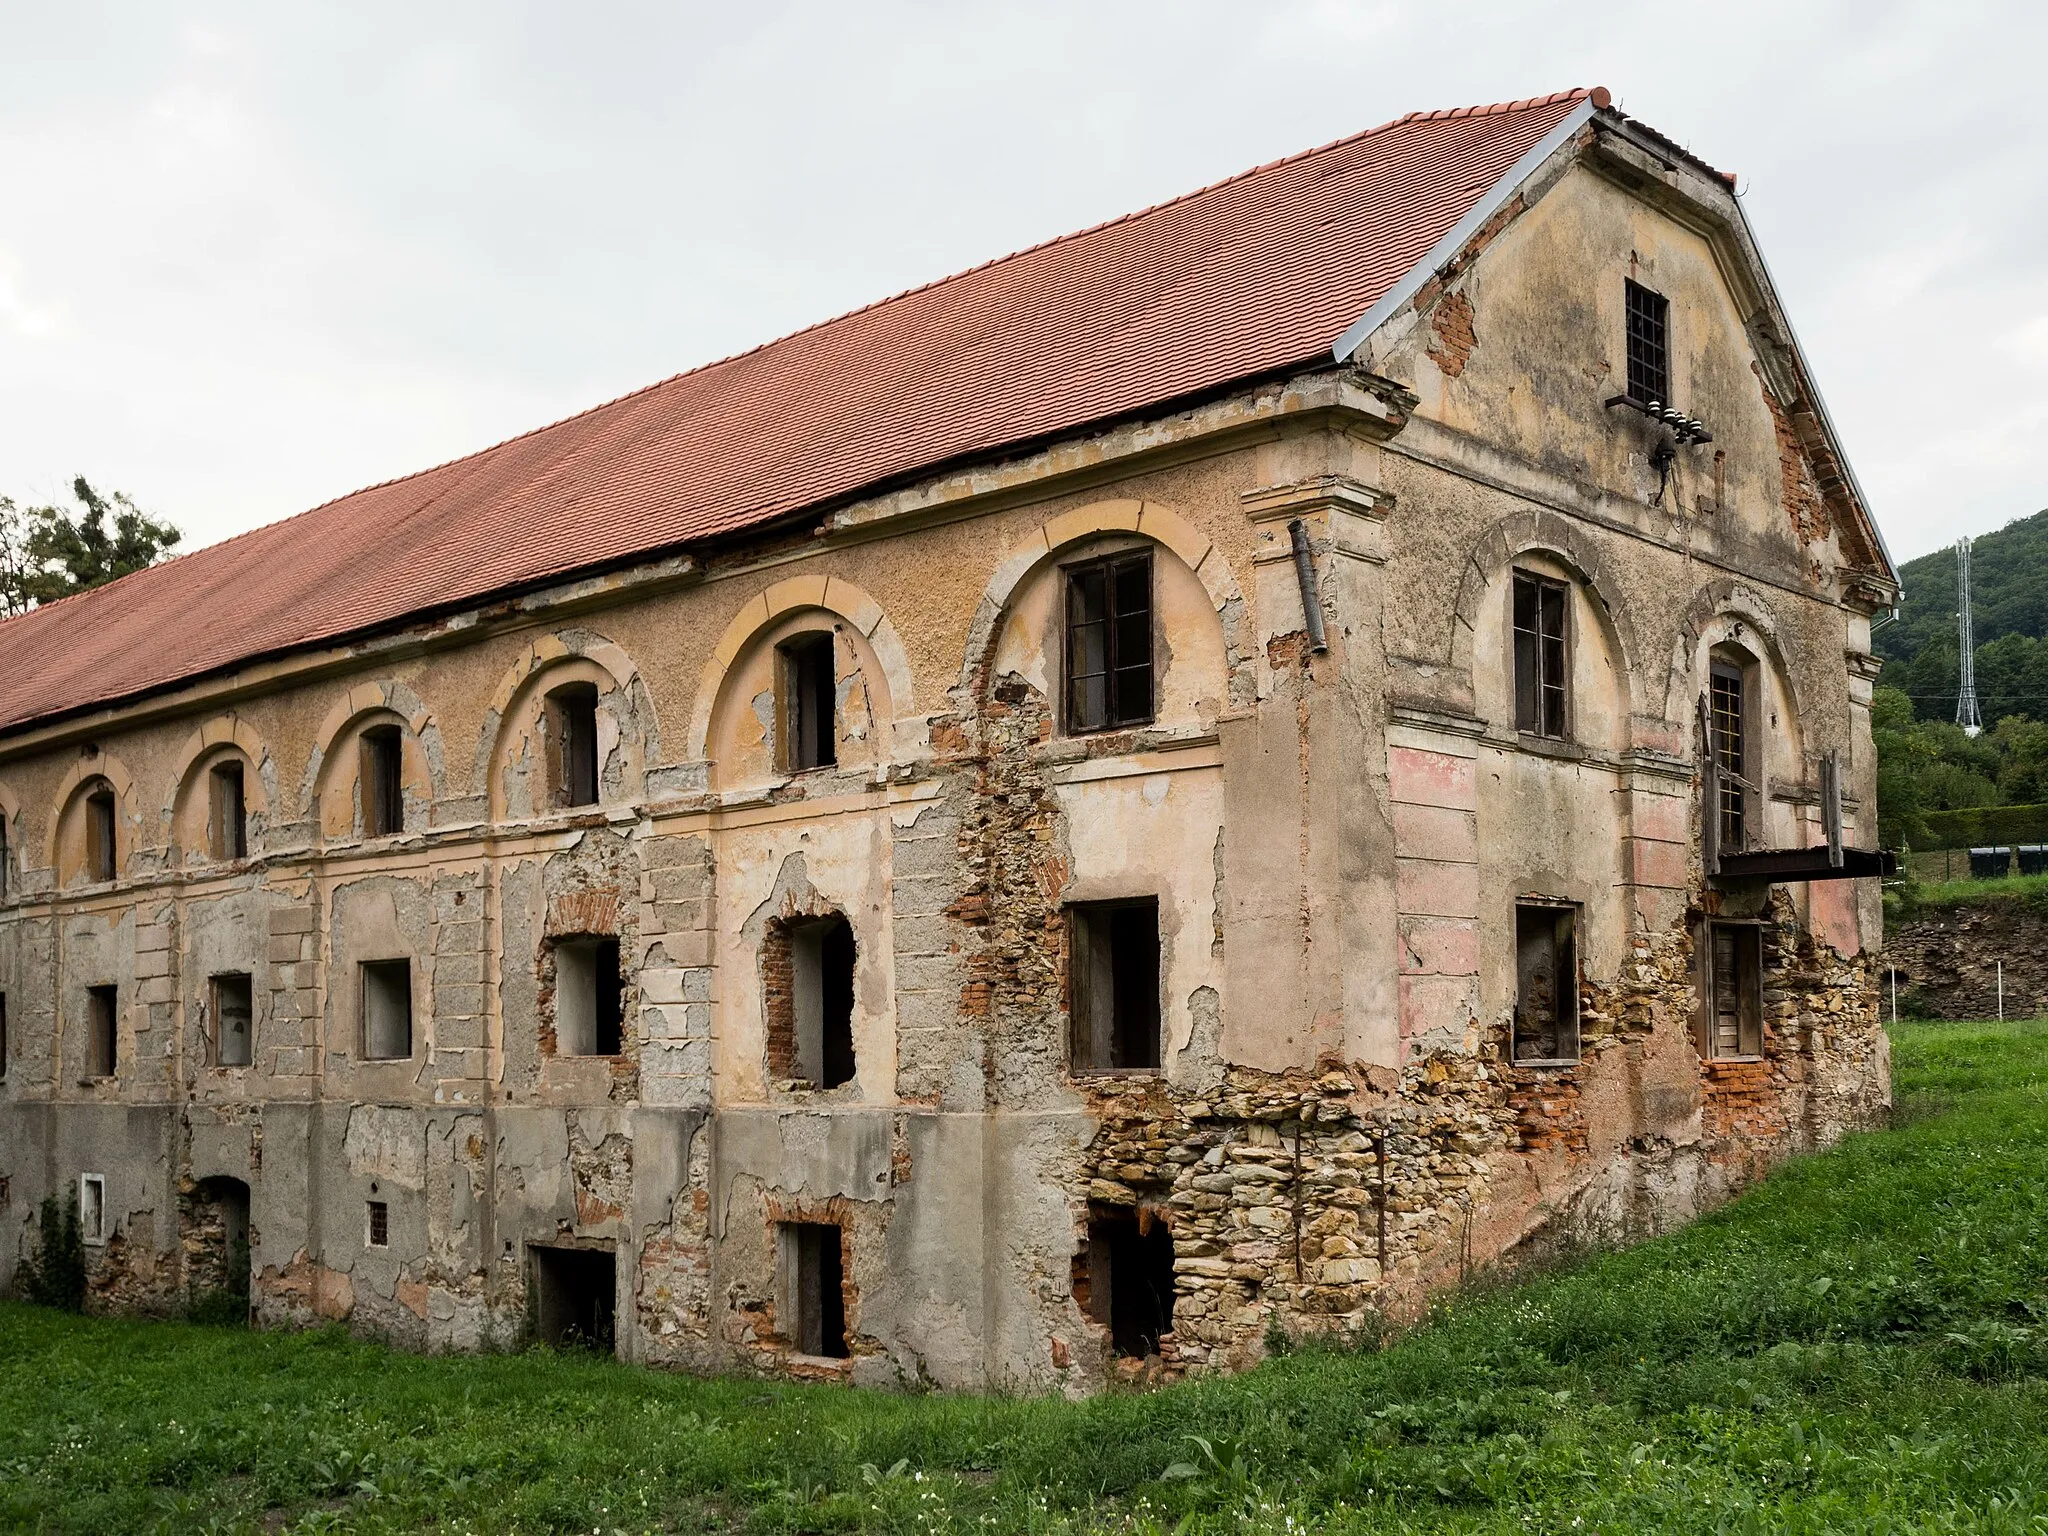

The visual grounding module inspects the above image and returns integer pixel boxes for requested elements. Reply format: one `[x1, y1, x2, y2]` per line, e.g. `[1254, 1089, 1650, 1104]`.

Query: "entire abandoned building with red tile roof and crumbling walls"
[0, 90, 1896, 1393]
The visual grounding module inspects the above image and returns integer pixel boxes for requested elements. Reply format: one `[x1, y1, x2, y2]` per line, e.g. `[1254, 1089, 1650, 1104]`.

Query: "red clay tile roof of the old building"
[0, 90, 1604, 731]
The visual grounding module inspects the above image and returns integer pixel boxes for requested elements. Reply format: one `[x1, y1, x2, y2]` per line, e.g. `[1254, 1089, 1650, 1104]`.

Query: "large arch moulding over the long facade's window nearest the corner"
[954, 500, 1262, 719]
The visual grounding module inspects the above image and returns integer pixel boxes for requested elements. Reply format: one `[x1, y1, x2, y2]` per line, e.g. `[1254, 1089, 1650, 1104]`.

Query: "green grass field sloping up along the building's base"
[0, 1024, 2048, 1532]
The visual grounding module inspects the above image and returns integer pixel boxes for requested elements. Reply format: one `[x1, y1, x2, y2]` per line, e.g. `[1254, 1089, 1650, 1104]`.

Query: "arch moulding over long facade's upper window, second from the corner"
[684, 575, 924, 782]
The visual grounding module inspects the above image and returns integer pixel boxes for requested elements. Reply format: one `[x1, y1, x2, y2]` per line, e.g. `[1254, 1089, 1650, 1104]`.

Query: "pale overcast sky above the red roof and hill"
[0, 0, 2048, 573]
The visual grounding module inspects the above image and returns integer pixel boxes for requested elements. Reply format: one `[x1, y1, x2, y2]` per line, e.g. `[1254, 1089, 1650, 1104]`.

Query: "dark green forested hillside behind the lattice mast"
[1872, 512, 2048, 727]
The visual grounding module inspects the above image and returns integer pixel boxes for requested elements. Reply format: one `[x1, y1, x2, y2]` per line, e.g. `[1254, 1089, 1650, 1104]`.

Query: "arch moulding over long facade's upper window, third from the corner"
[477, 631, 662, 821]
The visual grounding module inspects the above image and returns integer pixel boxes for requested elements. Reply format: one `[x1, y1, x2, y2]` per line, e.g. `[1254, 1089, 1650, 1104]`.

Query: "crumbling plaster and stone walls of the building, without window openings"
[0, 150, 1888, 1391]
